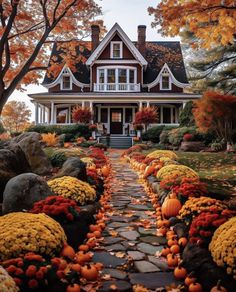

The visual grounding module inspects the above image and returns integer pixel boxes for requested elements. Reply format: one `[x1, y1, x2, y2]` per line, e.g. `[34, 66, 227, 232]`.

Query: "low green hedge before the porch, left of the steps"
[27, 124, 91, 139]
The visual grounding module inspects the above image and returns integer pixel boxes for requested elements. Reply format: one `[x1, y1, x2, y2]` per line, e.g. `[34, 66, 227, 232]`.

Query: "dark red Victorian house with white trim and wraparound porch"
[29, 23, 199, 135]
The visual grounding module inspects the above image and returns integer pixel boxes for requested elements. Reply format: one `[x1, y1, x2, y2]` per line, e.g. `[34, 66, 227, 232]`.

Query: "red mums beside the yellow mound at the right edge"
[189, 210, 235, 245]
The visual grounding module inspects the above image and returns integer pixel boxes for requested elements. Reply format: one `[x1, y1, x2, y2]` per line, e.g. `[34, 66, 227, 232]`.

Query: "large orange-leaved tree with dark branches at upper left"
[0, 0, 103, 114]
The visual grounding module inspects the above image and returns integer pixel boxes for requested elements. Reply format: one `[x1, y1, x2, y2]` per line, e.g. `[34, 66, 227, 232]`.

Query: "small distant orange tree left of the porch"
[2, 100, 31, 133]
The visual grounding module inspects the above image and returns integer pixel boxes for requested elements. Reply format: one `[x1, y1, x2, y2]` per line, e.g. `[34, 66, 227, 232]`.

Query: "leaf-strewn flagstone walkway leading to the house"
[93, 152, 176, 291]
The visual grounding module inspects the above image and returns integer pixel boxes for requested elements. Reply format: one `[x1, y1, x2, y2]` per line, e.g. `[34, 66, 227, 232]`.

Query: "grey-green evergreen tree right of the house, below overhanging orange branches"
[181, 30, 236, 95]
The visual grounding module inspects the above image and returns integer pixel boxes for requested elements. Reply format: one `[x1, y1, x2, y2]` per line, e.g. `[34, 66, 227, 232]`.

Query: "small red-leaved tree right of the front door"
[134, 107, 158, 131]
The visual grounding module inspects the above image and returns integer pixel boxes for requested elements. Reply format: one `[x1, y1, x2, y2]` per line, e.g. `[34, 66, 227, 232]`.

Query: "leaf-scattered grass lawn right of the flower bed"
[176, 152, 236, 194]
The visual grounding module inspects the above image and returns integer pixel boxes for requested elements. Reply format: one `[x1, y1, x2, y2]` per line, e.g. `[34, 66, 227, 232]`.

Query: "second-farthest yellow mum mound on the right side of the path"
[157, 164, 199, 180]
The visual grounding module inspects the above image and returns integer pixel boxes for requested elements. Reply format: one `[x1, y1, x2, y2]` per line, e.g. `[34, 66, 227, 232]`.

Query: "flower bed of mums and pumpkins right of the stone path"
[123, 150, 236, 291]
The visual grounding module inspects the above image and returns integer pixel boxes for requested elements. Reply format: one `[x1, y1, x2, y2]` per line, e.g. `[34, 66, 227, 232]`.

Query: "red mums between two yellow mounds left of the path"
[30, 196, 80, 223]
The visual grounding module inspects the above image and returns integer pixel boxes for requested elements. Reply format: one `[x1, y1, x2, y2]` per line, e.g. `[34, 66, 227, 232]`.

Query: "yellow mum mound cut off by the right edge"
[209, 217, 236, 280]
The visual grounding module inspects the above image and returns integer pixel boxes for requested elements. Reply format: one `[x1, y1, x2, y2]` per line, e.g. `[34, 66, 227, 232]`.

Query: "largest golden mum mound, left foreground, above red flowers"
[0, 212, 66, 260]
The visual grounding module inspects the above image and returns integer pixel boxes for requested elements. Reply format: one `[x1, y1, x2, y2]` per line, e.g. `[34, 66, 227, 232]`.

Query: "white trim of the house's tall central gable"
[86, 23, 148, 66]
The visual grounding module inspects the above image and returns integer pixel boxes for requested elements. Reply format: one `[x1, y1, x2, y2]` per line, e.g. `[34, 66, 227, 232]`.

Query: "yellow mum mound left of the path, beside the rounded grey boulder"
[48, 176, 96, 205]
